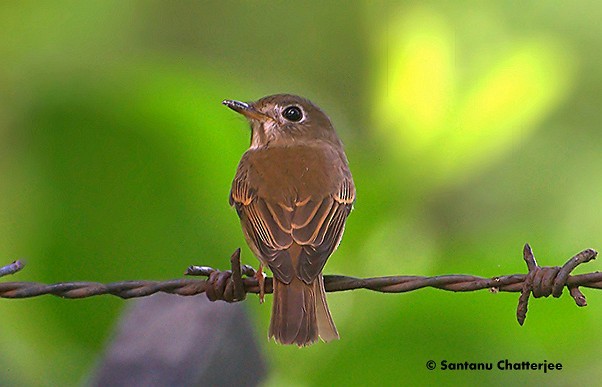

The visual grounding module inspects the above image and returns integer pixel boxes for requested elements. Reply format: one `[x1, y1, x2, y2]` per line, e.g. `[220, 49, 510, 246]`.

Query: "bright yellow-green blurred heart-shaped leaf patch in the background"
[374, 6, 571, 189]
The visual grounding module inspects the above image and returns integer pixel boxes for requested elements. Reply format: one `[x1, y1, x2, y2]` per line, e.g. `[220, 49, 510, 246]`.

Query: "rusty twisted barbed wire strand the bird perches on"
[0, 244, 602, 325]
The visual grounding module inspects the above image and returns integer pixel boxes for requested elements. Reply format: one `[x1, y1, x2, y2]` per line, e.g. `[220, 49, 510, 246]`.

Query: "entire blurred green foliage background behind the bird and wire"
[0, 1, 602, 386]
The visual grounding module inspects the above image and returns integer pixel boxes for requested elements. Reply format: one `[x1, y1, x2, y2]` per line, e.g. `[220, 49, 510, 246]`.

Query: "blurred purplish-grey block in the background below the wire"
[89, 293, 266, 386]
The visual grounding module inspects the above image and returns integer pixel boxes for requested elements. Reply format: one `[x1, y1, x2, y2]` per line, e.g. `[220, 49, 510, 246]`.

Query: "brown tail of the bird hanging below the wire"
[269, 274, 339, 347]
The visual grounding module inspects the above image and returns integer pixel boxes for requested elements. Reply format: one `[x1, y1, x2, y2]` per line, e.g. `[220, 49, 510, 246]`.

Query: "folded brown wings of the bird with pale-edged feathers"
[230, 155, 355, 284]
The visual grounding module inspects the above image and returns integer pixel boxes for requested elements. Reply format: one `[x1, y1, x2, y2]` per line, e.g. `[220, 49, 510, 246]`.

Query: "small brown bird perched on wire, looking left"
[223, 94, 355, 346]
